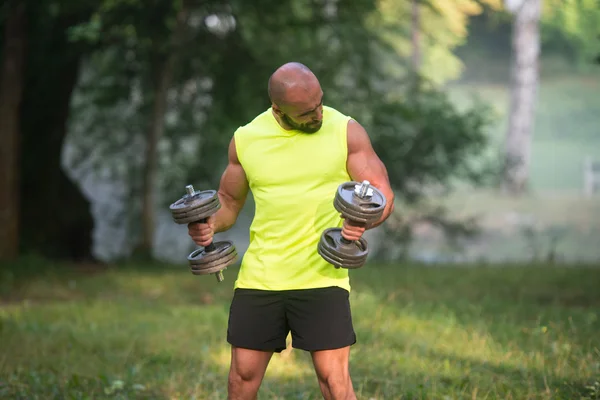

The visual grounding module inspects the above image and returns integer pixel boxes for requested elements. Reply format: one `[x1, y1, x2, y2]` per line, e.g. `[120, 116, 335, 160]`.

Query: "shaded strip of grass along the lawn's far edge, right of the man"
[351, 265, 600, 334]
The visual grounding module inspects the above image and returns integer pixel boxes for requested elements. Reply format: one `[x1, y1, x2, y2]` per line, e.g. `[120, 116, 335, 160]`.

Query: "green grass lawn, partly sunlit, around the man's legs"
[0, 261, 600, 400]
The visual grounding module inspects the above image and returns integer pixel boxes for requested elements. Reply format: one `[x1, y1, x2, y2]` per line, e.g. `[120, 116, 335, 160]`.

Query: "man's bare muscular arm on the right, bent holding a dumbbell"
[346, 120, 394, 229]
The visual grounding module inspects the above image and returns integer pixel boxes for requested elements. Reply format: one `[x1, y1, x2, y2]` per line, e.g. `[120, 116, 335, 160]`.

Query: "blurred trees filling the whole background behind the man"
[0, 0, 600, 266]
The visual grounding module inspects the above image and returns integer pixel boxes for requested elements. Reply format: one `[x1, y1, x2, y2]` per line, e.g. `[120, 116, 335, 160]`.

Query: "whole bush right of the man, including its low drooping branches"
[369, 77, 501, 260]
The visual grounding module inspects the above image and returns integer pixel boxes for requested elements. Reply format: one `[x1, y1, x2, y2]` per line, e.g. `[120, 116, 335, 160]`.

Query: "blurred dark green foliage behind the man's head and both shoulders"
[57, 0, 496, 260]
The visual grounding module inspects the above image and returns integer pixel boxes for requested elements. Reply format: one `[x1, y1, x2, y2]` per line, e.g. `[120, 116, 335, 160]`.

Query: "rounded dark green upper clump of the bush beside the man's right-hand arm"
[371, 79, 493, 203]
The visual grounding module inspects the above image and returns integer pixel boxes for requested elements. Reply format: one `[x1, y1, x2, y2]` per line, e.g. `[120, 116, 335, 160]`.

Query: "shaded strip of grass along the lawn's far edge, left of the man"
[0, 258, 244, 305]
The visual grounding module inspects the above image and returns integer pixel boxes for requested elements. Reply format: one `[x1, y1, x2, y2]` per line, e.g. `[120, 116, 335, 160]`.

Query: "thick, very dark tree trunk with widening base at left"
[20, 8, 94, 261]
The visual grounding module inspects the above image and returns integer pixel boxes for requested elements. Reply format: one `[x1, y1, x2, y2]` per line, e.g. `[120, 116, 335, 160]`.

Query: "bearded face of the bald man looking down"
[277, 90, 323, 133]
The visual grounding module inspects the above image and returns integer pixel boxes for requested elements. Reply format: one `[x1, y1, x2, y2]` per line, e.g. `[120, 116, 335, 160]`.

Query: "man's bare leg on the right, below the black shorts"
[311, 346, 356, 400]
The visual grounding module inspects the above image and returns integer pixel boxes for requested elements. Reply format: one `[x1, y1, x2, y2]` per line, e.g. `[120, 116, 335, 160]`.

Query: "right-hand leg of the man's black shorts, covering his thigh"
[286, 286, 356, 351]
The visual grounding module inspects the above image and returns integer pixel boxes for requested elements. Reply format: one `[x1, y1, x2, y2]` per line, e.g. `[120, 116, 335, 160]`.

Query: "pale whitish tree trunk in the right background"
[504, 0, 541, 195]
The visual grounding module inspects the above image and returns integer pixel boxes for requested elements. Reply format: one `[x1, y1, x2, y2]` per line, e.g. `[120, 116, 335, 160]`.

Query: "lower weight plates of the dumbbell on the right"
[317, 228, 369, 268]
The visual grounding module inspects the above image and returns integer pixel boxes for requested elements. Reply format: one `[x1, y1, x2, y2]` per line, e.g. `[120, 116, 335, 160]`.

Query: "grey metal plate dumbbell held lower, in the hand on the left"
[169, 185, 237, 282]
